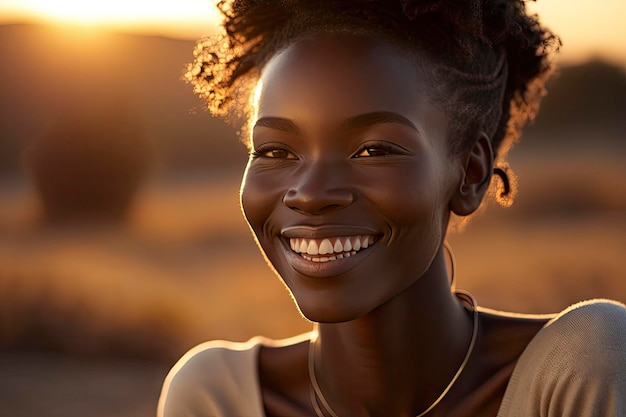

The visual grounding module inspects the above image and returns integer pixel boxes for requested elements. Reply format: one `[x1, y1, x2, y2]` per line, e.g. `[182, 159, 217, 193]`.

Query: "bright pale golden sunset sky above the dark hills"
[0, 0, 626, 66]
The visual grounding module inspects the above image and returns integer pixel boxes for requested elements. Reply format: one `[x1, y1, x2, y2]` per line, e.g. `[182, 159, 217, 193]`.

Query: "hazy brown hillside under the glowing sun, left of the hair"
[0, 25, 241, 180]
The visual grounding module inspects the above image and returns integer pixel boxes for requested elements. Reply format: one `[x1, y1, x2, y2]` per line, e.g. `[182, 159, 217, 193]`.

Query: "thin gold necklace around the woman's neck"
[308, 291, 478, 417]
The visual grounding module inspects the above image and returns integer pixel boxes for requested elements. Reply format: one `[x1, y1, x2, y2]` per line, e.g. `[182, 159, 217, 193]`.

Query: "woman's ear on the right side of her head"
[450, 132, 494, 216]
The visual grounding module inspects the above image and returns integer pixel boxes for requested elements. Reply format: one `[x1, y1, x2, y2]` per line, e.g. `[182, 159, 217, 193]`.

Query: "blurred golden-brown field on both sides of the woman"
[0, 144, 626, 417]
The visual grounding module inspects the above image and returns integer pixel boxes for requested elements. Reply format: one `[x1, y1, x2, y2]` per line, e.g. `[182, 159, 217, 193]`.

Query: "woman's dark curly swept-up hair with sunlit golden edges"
[185, 0, 560, 203]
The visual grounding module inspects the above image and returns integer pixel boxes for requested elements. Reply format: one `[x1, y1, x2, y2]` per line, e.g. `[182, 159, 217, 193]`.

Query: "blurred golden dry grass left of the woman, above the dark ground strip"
[0, 174, 309, 360]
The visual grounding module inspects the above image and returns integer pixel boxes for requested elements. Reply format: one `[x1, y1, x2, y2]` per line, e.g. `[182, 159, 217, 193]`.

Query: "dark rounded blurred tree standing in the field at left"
[24, 98, 151, 224]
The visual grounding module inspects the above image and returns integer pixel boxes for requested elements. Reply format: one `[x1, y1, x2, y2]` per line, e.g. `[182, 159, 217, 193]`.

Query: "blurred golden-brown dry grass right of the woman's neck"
[450, 149, 626, 312]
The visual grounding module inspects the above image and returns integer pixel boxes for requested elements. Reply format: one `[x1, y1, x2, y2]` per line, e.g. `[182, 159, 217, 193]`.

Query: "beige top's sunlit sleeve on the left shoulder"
[157, 339, 264, 417]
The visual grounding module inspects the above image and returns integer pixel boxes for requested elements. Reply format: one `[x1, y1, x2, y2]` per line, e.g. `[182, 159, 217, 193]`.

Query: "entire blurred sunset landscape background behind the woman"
[0, 0, 626, 417]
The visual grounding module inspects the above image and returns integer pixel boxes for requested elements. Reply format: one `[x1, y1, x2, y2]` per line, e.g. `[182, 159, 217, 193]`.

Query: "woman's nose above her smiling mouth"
[283, 163, 354, 215]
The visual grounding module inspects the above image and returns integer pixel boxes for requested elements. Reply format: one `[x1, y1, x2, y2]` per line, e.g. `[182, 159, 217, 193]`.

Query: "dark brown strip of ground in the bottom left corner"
[0, 352, 167, 417]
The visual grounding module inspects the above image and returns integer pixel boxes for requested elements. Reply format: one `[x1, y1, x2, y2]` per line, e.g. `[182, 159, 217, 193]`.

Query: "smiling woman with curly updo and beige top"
[159, 0, 626, 417]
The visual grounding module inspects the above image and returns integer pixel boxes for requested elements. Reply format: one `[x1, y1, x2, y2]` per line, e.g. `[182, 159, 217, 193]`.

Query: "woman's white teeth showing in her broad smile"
[289, 235, 376, 262]
